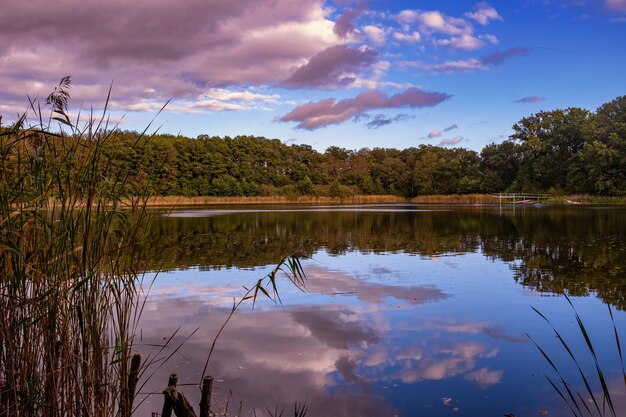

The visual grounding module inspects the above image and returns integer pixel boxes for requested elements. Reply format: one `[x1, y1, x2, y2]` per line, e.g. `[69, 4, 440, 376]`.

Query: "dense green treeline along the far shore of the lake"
[6, 96, 626, 197]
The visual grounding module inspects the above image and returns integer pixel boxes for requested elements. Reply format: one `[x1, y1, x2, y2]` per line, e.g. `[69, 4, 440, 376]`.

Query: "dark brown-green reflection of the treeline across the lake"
[149, 206, 626, 309]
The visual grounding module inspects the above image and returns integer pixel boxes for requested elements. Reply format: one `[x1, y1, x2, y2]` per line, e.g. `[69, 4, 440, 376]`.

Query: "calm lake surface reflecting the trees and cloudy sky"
[135, 204, 626, 417]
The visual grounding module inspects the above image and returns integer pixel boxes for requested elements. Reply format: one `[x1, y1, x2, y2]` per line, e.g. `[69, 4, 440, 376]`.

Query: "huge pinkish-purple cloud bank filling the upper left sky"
[0, 0, 341, 110]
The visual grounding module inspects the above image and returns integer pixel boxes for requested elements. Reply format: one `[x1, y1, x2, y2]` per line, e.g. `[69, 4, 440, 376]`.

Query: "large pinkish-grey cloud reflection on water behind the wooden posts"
[138, 287, 392, 417]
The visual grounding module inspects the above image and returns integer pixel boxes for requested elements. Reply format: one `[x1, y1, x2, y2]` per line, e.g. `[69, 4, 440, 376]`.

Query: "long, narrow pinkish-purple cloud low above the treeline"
[279, 87, 451, 130]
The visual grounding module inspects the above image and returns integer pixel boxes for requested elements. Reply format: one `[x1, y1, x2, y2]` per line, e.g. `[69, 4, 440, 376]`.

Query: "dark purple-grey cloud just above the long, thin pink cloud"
[283, 45, 378, 88]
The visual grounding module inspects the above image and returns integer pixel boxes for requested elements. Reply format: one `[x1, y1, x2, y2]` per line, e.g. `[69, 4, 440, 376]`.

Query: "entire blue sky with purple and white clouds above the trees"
[0, 0, 626, 151]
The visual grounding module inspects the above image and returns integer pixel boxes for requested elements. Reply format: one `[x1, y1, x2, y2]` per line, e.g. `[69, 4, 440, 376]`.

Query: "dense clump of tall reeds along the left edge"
[0, 77, 151, 417]
